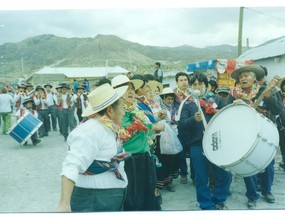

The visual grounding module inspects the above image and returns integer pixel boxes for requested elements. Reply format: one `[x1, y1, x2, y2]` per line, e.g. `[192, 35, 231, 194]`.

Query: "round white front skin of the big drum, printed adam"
[203, 104, 259, 166]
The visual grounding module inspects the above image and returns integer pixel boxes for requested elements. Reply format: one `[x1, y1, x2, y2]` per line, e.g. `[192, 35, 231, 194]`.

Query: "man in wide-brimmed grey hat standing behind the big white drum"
[227, 65, 282, 209]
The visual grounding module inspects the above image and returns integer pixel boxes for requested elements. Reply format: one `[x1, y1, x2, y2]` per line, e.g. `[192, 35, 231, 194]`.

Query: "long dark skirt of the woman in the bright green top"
[124, 152, 161, 211]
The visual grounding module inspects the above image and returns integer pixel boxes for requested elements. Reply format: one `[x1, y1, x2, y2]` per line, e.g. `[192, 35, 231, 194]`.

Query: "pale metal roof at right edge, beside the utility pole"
[237, 37, 285, 60]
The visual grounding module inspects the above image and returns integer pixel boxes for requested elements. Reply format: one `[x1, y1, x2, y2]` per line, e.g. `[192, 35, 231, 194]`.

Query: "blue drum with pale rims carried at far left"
[8, 112, 43, 145]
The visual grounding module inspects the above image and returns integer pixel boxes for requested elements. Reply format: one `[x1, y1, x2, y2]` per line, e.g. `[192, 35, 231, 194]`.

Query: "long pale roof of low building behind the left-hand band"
[35, 66, 128, 78]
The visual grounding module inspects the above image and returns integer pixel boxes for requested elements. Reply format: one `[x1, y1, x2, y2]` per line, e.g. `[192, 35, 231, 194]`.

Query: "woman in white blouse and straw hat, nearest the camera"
[57, 84, 129, 212]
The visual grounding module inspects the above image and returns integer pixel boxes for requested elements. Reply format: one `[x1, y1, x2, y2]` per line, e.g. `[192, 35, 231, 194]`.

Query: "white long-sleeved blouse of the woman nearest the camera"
[61, 119, 128, 189]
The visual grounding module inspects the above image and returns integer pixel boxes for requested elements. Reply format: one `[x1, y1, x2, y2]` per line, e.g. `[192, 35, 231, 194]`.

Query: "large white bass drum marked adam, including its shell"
[203, 104, 279, 177]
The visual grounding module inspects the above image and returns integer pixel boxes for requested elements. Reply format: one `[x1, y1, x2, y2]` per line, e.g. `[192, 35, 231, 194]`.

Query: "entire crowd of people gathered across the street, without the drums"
[0, 64, 285, 212]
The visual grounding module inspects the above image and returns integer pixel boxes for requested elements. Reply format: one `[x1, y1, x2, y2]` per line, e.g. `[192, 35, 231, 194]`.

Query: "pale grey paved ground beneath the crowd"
[0, 119, 285, 212]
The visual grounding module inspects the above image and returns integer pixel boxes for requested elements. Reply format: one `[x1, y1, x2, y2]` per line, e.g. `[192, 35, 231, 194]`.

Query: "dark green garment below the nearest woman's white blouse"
[70, 187, 126, 212]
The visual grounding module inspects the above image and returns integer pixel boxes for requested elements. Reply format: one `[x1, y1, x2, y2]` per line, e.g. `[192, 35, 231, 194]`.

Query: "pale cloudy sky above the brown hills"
[0, 0, 285, 48]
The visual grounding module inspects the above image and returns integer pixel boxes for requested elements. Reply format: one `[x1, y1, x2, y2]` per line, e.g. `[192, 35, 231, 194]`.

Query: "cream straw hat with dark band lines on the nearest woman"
[82, 84, 128, 117]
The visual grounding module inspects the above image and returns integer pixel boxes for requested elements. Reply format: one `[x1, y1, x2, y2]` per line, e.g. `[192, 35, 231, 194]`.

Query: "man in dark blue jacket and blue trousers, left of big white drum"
[179, 73, 231, 210]
